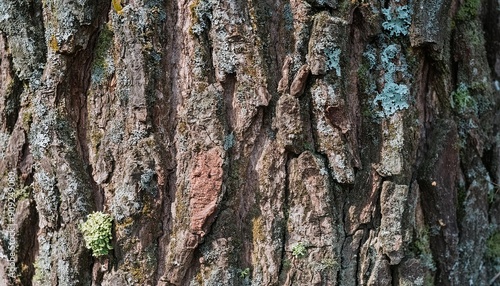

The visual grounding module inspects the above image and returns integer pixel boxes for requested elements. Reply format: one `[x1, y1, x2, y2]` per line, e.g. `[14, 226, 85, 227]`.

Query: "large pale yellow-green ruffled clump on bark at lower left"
[79, 212, 113, 257]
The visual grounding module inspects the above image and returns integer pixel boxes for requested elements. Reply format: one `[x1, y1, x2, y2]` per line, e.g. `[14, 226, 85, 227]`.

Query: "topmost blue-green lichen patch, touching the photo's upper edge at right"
[382, 5, 412, 36]
